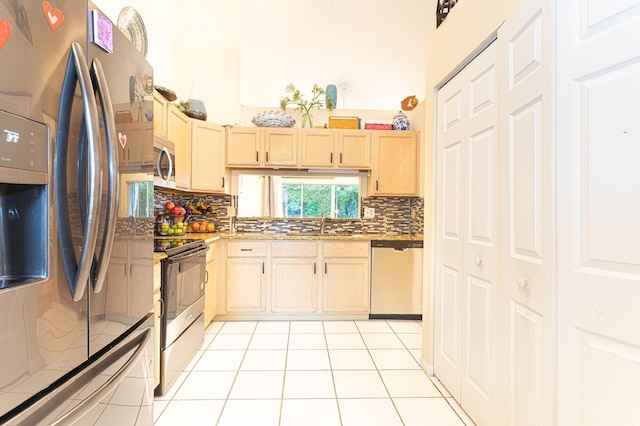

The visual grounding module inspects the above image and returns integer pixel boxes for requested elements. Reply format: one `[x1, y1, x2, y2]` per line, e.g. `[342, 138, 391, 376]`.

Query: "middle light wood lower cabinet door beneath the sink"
[271, 258, 318, 313]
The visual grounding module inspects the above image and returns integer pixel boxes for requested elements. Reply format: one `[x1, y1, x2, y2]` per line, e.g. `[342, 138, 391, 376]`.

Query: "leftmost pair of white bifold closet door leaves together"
[434, 43, 498, 425]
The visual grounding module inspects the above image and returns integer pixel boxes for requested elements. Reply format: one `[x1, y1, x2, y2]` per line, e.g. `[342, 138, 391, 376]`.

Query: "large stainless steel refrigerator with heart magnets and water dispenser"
[0, 0, 154, 425]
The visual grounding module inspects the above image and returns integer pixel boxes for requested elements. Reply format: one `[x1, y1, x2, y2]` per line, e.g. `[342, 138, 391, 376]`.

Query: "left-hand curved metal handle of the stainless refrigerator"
[53, 42, 102, 302]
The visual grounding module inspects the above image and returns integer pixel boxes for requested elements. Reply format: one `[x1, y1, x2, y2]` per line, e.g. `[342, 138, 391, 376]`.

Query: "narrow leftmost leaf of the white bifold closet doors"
[434, 61, 468, 402]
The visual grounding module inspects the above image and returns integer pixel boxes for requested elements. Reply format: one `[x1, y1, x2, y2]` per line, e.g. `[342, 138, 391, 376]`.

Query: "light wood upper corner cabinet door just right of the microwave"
[191, 120, 228, 192]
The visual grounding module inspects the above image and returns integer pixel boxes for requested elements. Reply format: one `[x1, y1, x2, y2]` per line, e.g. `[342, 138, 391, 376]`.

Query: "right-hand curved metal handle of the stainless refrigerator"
[91, 59, 120, 293]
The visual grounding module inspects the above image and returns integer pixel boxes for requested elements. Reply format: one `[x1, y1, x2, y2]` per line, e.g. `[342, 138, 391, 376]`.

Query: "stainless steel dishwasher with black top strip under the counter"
[369, 240, 423, 319]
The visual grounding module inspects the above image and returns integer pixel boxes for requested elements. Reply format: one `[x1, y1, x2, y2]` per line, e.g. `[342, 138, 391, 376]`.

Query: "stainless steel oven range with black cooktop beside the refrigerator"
[155, 238, 207, 395]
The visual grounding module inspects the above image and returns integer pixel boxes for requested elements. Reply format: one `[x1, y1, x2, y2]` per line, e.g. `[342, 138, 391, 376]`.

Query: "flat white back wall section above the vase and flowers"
[240, 0, 432, 110]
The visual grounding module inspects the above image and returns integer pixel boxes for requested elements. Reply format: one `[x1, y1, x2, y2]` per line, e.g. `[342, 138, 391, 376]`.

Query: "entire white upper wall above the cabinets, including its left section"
[97, 0, 435, 125]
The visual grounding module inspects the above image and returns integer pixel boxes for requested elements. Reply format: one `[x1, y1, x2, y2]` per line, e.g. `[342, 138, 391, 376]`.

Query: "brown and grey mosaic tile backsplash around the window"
[154, 190, 424, 235]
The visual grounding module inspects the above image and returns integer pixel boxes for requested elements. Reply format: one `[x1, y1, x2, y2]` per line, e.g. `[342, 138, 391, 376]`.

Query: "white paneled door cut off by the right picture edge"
[557, 0, 640, 425]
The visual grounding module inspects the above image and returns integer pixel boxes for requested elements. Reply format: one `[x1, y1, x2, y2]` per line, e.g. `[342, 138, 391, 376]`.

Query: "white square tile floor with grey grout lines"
[154, 320, 473, 426]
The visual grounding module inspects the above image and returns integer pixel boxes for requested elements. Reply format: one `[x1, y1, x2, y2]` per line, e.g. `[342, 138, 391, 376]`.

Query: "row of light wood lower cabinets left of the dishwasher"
[217, 240, 370, 315]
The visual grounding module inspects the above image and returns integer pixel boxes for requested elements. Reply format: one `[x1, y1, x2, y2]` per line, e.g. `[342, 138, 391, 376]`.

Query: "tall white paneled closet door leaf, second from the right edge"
[498, 0, 555, 426]
